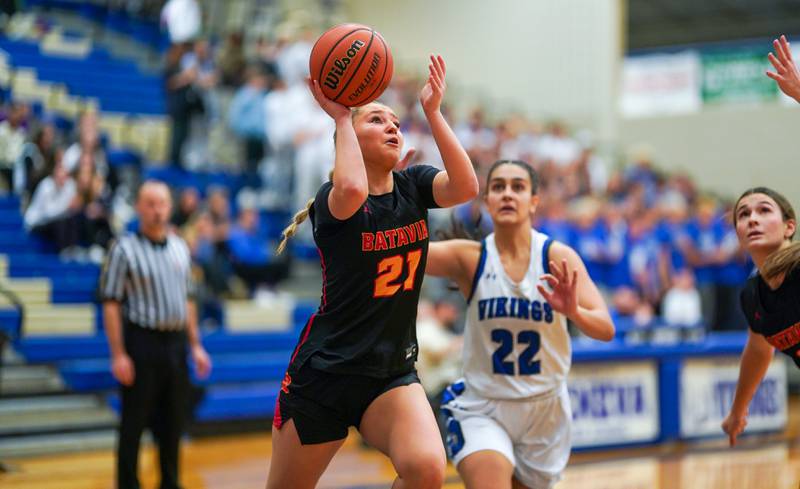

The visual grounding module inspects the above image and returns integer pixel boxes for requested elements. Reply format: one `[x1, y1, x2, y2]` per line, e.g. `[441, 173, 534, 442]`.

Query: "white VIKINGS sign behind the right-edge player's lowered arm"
[680, 357, 787, 437]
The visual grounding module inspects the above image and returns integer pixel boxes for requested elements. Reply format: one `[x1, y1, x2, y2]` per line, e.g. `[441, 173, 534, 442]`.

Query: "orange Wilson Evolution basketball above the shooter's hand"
[309, 24, 394, 107]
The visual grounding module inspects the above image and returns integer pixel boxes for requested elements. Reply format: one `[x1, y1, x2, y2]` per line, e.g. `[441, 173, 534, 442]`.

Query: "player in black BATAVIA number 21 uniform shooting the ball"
[267, 56, 478, 489]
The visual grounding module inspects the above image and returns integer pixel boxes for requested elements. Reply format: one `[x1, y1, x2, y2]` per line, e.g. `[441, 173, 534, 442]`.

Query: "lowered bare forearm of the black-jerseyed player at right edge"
[722, 331, 775, 446]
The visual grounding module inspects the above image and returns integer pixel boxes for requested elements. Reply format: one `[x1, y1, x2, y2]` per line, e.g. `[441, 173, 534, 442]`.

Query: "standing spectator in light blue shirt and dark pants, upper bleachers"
[228, 63, 274, 187]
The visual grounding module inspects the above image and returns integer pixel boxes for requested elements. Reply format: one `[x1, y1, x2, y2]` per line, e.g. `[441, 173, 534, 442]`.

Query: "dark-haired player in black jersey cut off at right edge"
[722, 187, 800, 446]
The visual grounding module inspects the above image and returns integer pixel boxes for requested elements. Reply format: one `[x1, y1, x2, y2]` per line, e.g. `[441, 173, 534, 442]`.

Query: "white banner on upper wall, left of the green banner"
[620, 51, 703, 117]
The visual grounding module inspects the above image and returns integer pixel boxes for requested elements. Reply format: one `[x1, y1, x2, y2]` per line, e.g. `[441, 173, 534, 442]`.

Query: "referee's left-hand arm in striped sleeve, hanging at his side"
[100, 243, 136, 386]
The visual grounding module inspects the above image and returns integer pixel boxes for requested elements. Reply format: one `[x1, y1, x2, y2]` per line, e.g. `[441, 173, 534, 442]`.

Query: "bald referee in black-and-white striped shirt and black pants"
[100, 180, 211, 489]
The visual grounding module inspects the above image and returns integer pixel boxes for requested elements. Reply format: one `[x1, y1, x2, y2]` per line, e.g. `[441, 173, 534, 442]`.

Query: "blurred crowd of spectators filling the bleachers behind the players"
[0, 0, 752, 329]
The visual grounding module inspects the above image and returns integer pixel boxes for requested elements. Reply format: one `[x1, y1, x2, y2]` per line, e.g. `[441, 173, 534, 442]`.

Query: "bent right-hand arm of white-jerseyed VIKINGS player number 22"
[538, 242, 614, 341]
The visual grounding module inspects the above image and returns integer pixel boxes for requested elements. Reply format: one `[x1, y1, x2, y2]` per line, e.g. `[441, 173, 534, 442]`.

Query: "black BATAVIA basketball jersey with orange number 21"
[290, 165, 439, 377]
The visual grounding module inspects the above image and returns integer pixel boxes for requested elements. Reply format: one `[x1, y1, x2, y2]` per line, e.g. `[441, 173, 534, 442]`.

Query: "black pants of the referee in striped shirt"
[117, 325, 189, 489]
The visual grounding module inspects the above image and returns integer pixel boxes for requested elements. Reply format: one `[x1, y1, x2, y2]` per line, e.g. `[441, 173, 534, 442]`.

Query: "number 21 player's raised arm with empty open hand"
[419, 55, 478, 207]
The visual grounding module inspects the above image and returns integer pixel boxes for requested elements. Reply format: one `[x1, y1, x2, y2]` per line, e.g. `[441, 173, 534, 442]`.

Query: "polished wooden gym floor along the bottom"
[0, 399, 800, 489]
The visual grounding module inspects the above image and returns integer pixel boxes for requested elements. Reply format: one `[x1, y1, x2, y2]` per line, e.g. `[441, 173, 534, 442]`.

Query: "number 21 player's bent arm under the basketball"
[308, 79, 369, 220]
